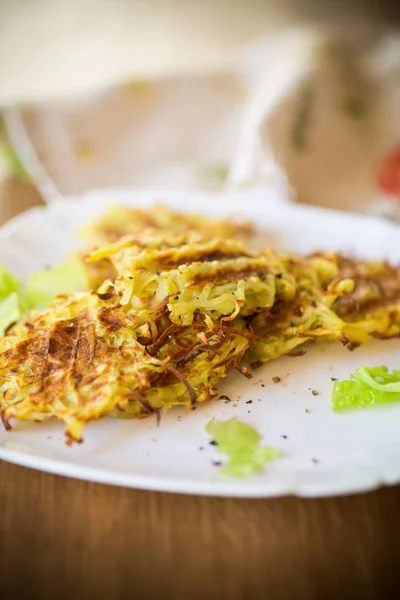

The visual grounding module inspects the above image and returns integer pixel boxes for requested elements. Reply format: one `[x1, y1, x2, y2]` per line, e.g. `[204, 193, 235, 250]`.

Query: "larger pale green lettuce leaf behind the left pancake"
[25, 256, 89, 308]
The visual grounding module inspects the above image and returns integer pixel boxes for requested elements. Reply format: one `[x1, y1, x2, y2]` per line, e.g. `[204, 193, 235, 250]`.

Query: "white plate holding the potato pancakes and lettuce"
[0, 191, 400, 497]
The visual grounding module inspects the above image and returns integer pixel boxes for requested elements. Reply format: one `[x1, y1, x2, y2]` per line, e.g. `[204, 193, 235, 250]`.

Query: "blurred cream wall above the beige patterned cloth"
[0, 0, 400, 103]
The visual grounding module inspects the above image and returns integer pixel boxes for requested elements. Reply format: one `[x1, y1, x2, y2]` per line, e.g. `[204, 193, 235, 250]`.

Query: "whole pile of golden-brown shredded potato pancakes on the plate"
[0, 207, 400, 443]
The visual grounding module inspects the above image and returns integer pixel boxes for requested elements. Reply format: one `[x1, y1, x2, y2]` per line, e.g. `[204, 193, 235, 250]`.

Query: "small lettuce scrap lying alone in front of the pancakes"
[206, 418, 280, 477]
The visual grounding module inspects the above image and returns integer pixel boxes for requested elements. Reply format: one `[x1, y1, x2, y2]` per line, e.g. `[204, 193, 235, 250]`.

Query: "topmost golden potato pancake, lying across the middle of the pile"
[88, 232, 295, 325]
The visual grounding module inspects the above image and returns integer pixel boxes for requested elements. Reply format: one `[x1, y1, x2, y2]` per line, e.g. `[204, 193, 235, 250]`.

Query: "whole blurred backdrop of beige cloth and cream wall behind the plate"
[0, 0, 400, 221]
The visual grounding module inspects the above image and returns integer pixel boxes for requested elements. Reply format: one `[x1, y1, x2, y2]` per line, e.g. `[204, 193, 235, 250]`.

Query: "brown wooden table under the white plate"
[0, 181, 400, 600]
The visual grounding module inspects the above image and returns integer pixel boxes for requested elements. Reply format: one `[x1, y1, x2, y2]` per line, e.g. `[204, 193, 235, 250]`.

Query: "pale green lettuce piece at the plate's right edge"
[332, 365, 400, 412]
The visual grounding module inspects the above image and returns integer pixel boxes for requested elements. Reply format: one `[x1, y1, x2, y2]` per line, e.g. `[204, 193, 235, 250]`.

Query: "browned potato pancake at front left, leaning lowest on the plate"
[0, 292, 249, 441]
